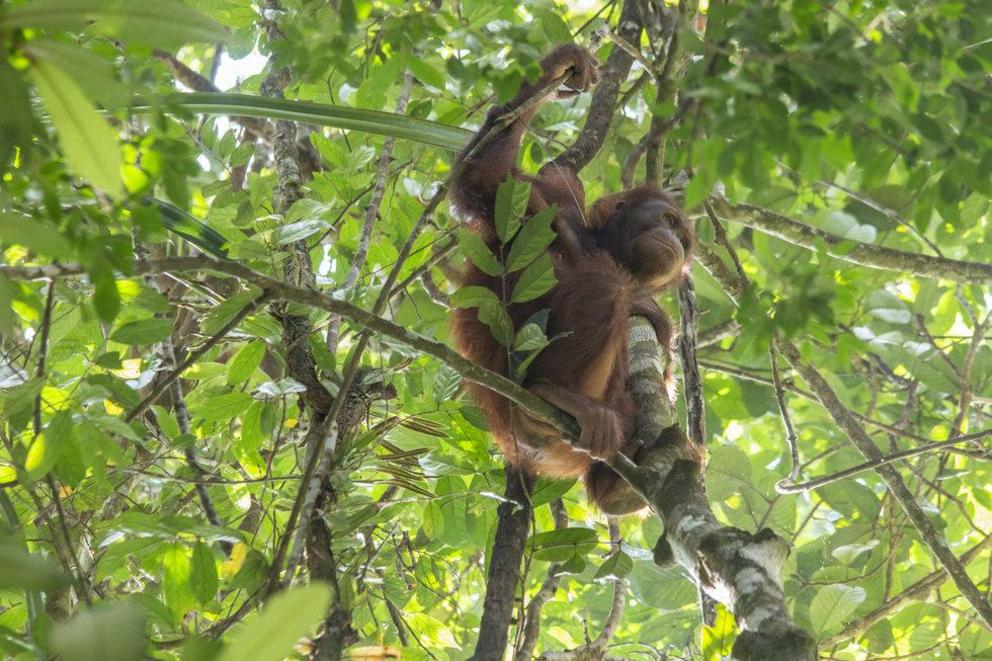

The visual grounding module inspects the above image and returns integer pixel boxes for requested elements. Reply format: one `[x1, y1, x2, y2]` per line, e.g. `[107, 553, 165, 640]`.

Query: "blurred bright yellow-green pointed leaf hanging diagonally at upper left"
[31, 58, 121, 194]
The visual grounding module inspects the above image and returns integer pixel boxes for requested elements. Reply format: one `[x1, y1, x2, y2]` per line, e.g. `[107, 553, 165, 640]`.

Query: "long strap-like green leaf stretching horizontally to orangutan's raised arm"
[131, 92, 472, 151]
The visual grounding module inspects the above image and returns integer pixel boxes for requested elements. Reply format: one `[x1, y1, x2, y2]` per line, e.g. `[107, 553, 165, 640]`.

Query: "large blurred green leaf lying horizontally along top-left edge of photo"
[0, 0, 228, 48]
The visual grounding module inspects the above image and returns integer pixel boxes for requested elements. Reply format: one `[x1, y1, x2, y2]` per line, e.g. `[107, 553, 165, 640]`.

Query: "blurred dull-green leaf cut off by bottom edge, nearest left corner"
[52, 602, 146, 661]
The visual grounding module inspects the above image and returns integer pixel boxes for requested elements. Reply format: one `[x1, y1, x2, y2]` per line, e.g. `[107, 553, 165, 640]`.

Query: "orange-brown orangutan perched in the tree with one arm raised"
[452, 46, 692, 513]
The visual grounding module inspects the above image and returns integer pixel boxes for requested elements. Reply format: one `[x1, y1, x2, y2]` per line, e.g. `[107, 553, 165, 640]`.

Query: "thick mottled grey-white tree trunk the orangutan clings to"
[614, 318, 816, 661]
